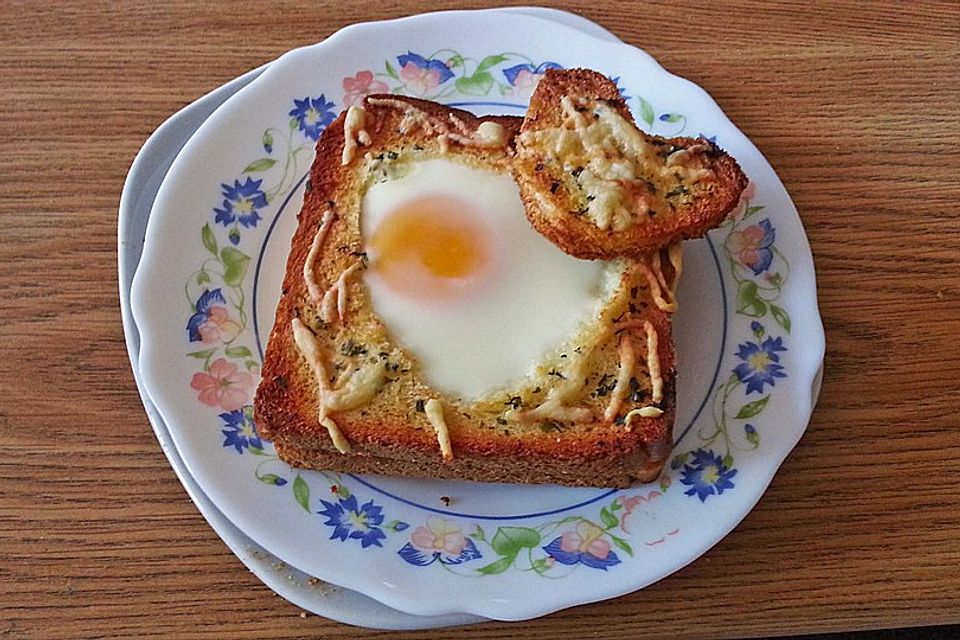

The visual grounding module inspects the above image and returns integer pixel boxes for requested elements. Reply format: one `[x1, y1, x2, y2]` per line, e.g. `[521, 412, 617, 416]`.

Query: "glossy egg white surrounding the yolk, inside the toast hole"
[360, 158, 622, 400]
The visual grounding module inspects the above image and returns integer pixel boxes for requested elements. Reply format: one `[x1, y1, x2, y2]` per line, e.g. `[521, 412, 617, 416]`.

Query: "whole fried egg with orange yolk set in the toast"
[360, 158, 611, 400]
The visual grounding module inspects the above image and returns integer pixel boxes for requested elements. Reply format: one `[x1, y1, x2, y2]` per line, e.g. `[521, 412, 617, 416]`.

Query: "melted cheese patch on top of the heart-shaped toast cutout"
[520, 96, 713, 231]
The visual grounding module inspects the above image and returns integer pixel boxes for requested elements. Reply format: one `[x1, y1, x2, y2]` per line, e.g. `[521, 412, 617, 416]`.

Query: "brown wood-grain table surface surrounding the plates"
[0, 0, 960, 639]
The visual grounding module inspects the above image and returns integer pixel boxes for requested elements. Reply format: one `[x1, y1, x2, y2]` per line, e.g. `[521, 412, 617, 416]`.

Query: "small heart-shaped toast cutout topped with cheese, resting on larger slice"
[514, 69, 747, 259]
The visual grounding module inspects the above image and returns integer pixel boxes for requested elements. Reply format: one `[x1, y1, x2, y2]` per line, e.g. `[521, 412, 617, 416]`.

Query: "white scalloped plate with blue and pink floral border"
[132, 7, 823, 619]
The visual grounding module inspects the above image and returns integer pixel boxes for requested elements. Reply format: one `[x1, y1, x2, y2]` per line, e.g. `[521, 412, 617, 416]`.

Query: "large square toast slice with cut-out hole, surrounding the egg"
[255, 95, 680, 487]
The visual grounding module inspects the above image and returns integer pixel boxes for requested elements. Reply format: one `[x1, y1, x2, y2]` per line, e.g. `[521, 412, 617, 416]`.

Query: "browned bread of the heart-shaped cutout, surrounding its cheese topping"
[513, 69, 747, 260]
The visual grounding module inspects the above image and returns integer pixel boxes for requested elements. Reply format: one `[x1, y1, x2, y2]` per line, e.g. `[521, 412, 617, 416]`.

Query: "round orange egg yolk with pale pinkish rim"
[369, 195, 491, 298]
